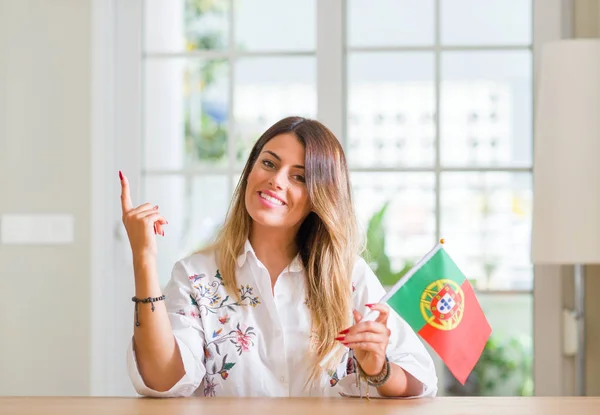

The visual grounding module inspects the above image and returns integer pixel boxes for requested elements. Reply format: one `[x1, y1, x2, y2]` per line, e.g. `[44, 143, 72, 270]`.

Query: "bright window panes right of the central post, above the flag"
[346, 0, 532, 290]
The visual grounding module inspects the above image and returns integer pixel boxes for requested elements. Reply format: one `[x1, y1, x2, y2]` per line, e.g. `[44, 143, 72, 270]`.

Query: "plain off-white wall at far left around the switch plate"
[0, 0, 90, 395]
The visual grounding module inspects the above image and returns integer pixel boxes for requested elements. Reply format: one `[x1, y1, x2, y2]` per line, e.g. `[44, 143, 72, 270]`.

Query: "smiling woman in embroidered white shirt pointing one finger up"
[119, 117, 437, 397]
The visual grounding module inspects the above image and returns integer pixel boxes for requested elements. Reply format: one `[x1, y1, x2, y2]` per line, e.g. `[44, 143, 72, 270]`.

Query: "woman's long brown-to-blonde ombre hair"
[209, 117, 361, 382]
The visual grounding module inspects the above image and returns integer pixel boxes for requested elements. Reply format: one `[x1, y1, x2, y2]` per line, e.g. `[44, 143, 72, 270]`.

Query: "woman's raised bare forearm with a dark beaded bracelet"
[133, 257, 185, 392]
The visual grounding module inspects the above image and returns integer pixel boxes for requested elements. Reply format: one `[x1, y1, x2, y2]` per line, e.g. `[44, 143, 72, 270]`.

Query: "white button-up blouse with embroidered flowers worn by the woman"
[127, 241, 437, 397]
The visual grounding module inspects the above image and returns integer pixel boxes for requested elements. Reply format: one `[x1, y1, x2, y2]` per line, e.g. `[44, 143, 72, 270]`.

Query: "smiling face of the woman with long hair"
[245, 133, 311, 229]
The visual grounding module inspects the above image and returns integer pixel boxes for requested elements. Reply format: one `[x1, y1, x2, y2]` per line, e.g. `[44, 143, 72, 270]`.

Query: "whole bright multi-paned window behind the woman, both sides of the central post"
[140, 0, 533, 395]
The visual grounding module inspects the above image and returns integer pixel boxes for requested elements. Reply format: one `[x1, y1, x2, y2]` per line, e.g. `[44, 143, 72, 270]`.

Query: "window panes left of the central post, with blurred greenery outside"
[142, 0, 317, 283]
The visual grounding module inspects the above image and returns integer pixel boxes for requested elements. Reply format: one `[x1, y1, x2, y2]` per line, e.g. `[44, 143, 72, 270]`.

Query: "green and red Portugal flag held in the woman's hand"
[381, 240, 492, 384]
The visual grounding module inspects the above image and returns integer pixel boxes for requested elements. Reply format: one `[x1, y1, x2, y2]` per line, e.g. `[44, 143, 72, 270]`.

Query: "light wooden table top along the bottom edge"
[0, 397, 600, 415]
